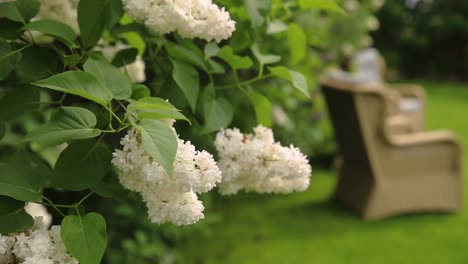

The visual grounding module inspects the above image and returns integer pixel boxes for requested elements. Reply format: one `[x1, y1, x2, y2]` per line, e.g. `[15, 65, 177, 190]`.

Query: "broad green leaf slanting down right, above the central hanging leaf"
[83, 54, 132, 100]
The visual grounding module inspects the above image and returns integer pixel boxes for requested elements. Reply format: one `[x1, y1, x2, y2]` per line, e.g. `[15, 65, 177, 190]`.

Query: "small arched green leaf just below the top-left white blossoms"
[22, 19, 76, 47]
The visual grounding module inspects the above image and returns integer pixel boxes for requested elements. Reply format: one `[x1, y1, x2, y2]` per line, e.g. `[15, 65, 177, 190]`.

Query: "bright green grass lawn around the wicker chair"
[181, 83, 468, 264]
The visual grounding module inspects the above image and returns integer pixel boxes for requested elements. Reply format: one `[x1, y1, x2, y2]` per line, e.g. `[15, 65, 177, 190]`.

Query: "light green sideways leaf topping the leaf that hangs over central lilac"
[127, 97, 190, 123]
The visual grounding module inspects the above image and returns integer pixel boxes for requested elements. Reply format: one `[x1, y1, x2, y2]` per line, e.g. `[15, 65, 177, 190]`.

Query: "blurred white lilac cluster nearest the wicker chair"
[215, 126, 312, 195]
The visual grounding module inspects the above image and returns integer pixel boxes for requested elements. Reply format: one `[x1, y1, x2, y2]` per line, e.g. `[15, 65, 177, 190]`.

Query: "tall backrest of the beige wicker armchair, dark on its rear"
[322, 79, 386, 178]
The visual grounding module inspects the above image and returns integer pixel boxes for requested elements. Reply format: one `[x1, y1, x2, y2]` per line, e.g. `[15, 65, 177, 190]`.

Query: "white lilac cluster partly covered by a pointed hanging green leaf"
[112, 129, 221, 225]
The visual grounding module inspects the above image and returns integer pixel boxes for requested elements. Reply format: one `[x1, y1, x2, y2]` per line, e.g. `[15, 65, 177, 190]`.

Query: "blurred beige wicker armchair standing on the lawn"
[322, 79, 462, 219]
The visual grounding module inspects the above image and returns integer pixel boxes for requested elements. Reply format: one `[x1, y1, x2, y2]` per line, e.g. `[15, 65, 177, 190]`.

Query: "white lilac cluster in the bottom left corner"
[0, 217, 78, 264]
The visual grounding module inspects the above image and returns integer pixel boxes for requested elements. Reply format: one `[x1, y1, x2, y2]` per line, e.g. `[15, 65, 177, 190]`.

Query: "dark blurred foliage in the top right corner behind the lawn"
[372, 0, 468, 80]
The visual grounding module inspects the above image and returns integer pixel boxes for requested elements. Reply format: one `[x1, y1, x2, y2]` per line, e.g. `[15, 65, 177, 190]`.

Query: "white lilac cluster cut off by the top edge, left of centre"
[122, 0, 235, 42]
